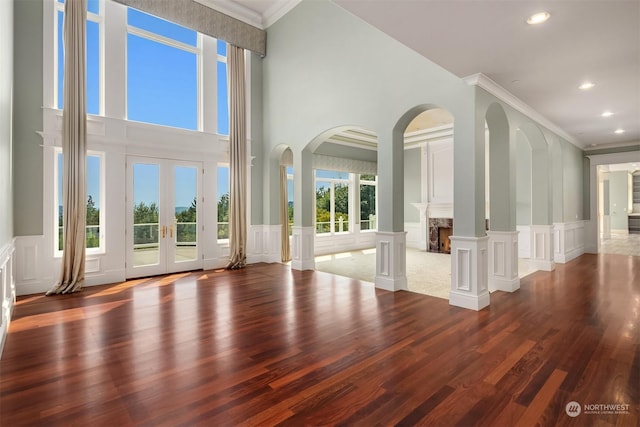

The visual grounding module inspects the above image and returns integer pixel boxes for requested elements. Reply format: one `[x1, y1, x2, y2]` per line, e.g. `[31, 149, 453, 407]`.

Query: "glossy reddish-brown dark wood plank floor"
[0, 255, 640, 426]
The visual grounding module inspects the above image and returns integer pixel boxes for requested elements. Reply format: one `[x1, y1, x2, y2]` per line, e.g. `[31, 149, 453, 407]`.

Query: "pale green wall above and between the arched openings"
[263, 0, 476, 235]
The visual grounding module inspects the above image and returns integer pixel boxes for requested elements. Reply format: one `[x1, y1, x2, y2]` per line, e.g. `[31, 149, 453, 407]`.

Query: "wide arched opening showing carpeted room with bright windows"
[292, 126, 378, 274]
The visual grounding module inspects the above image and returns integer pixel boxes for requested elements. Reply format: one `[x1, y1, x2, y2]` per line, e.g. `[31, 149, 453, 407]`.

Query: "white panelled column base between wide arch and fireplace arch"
[375, 231, 407, 291]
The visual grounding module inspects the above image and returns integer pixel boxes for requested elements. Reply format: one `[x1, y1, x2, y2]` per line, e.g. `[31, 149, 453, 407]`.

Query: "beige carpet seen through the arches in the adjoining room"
[316, 249, 533, 299]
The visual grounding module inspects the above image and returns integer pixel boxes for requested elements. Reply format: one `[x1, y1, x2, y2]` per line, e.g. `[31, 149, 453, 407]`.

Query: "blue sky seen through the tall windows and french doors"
[57, 0, 229, 216]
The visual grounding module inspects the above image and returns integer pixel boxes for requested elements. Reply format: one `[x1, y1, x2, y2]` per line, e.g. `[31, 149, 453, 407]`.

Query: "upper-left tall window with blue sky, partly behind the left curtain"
[55, 0, 103, 115]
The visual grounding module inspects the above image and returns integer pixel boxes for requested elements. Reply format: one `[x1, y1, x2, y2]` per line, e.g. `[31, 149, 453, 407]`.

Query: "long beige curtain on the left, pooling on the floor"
[47, 0, 87, 295]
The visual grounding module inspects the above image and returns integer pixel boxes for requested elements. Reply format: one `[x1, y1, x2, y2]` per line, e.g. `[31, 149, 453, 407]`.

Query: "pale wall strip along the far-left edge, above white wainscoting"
[0, 0, 13, 251]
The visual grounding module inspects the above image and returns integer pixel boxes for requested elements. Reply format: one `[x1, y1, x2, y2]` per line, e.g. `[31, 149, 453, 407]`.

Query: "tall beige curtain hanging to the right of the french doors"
[227, 45, 247, 269]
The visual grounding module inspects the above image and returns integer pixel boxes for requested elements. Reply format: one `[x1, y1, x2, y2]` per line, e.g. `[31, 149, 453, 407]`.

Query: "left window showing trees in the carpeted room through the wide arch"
[315, 170, 351, 234]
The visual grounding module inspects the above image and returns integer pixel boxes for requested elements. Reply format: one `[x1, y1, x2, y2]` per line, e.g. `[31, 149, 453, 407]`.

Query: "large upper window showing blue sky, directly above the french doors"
[127, 8, 201, 130]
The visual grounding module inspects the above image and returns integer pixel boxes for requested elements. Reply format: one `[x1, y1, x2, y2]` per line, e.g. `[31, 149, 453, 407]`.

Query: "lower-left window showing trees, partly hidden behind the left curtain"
[55, 151, 104, 253]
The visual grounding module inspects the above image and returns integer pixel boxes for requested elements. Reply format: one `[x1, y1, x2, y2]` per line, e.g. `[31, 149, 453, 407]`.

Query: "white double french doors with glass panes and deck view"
[126, 157, 202, 278]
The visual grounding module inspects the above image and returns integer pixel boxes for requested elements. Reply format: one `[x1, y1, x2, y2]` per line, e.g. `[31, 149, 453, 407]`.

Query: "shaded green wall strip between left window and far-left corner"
[12, 0, 43, 236]
